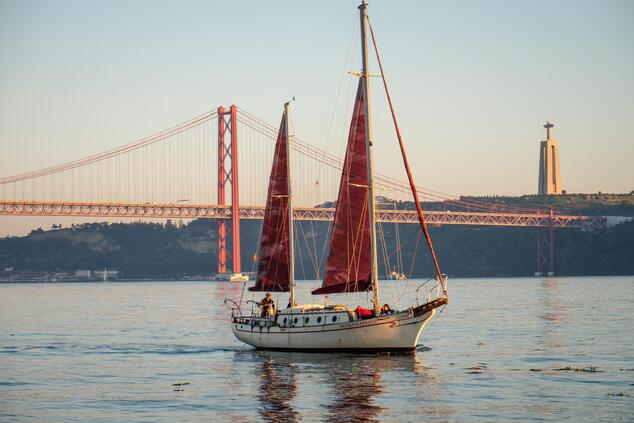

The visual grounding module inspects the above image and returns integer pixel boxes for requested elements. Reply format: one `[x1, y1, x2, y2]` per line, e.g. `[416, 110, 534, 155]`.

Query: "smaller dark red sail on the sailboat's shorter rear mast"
[249, 111, 291, 292]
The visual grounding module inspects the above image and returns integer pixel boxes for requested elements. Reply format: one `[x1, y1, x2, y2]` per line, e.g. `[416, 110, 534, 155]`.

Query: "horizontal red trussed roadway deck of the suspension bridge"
[0, 201, 607, 229]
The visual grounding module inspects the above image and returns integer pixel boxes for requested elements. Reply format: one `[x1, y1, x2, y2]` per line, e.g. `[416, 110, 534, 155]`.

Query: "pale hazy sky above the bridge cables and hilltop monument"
[0, 0, 634, 237]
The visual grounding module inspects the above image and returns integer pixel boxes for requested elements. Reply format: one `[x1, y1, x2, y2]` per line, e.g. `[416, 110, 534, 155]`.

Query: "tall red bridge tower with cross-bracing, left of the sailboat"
[218, 105, 241, 273]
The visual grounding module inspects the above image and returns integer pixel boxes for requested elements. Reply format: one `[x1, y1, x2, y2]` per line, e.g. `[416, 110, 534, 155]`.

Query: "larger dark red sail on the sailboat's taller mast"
[313, 79, 372, 295]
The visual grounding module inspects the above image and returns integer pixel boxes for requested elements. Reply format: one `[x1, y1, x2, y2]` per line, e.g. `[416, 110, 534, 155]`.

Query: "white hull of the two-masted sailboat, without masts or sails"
[231, 304, 442, 352]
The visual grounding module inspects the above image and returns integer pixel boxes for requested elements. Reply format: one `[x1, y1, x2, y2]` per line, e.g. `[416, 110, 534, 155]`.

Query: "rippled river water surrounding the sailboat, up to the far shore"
[0, 277, 634, 422]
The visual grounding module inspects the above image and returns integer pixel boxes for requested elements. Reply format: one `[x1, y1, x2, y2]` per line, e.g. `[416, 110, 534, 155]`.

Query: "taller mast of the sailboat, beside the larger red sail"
[359, 0, 381, 315]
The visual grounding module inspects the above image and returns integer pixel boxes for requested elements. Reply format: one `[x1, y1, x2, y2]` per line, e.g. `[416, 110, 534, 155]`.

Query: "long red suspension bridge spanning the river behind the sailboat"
[0, 105, 607, 274]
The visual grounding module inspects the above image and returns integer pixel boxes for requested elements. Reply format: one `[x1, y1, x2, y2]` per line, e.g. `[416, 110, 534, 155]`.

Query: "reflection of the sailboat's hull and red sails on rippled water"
[244, 351, 438, 422]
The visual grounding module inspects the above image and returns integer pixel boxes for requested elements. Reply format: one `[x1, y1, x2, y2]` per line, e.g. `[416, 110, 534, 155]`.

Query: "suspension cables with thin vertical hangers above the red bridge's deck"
[0, 105, 564, 217]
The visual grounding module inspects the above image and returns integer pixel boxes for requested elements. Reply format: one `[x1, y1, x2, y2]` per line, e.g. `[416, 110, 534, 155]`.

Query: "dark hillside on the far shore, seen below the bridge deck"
[0, 207, 634, 279]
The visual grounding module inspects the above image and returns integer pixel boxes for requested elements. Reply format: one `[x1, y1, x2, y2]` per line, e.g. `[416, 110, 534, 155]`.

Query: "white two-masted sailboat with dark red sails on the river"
[225, 1, 448, 352]
